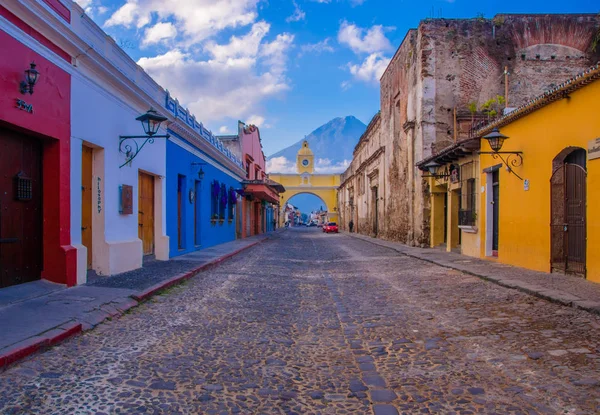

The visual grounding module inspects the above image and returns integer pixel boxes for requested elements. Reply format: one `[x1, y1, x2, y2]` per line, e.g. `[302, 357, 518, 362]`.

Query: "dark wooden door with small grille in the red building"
[0, 129, 43, 287]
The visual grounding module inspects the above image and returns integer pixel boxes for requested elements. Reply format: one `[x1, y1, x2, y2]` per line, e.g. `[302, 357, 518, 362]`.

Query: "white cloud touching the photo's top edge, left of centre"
[105, 0, 259, 45]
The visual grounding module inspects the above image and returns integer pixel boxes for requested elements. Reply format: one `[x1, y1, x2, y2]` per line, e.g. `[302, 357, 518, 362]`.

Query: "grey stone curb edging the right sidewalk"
[344, 232, 600, 315]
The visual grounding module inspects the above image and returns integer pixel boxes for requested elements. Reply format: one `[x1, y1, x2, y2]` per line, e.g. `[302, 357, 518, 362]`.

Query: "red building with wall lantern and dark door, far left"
[0, 4, 76, 287]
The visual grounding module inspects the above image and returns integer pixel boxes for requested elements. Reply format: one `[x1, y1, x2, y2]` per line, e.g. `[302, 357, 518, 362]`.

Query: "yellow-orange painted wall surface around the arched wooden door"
[478, 80, 600, 282]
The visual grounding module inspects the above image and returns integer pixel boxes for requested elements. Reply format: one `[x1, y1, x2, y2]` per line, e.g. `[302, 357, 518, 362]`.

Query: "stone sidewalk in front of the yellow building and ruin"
[344, 232, 600, 314]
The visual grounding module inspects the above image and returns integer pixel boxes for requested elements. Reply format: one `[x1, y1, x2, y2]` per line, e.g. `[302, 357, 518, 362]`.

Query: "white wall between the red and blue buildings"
[71, 72, 168, 282]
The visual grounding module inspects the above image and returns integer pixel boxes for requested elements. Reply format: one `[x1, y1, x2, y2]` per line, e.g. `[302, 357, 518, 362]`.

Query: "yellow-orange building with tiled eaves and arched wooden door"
[418, 65, 600, 282]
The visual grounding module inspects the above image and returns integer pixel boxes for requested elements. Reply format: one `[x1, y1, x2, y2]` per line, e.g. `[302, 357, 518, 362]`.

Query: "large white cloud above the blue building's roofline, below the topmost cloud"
[138, 22, 294, 122]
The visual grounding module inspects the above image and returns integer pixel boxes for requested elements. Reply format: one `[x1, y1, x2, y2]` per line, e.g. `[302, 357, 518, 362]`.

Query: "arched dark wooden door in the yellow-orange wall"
[550, 163, 587, 278]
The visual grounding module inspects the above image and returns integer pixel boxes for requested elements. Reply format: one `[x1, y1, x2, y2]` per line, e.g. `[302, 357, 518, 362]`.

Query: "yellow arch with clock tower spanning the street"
[269, 140, 340, 225]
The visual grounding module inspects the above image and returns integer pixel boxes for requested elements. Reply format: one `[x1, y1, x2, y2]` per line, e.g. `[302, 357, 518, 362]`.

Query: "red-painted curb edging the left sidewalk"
[0, 237, 269, 372]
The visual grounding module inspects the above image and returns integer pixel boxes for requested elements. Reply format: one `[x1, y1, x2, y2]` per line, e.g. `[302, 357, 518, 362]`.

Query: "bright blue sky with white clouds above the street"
[76, 0, 600, 161]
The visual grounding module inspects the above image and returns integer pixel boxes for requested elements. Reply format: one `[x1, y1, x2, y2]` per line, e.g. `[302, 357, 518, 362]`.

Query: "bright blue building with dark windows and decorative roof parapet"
[166, 93, 246, 257]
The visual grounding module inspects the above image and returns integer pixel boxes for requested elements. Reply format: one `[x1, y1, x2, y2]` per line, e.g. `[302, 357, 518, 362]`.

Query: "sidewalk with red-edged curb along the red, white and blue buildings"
[0, 234, 269, 370]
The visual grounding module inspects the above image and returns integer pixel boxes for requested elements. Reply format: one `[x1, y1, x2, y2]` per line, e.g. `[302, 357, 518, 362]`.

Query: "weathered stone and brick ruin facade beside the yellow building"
[339, 15, 600, 246]
